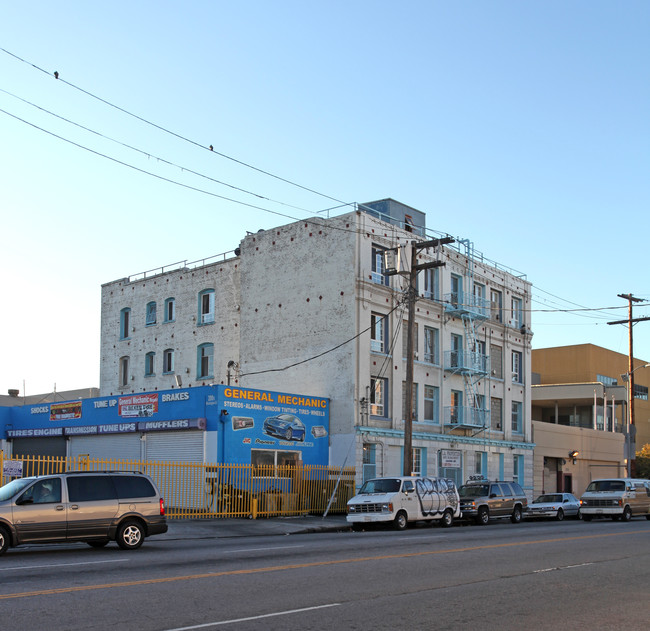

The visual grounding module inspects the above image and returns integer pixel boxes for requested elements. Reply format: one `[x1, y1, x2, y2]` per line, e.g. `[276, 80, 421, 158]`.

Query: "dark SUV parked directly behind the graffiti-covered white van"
[458, 478, 528, 526]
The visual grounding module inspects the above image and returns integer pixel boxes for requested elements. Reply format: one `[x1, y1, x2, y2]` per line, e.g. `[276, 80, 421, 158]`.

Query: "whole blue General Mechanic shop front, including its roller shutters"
[0, 386, 329, 465]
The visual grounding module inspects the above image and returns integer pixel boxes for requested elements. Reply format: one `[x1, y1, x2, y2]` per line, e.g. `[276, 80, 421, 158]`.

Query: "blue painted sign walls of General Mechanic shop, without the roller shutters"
[0, 386, 329, 465]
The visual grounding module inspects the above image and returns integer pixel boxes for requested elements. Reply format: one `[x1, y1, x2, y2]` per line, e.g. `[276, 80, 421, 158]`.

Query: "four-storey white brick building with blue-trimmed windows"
[100, 200, 533, 489]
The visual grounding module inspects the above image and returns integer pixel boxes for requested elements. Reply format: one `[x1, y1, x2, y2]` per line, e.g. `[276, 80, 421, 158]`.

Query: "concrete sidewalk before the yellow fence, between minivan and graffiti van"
[156, 515, 350, 539]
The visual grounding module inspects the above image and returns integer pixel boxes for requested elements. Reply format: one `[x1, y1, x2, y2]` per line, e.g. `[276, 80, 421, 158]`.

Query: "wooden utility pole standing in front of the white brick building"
[384, 237, 455, 476]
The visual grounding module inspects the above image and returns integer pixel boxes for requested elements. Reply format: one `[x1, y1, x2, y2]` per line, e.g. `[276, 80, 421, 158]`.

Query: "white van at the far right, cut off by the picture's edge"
[580, 478, 650, 521]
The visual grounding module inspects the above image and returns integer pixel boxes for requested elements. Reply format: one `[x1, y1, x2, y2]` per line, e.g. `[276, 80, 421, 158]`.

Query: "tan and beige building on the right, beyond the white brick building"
[532, 344, 650, 495]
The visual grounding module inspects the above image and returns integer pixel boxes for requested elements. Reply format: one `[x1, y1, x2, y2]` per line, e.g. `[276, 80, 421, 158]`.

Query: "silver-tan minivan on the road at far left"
[0, 471, 167, 554]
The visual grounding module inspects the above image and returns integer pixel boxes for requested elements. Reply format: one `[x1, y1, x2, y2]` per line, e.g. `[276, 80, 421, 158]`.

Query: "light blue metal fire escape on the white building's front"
[444, 239, 490, 430]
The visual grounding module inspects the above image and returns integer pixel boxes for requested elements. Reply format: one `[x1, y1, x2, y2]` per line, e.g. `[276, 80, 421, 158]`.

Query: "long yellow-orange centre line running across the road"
[0, 530, 648, 600]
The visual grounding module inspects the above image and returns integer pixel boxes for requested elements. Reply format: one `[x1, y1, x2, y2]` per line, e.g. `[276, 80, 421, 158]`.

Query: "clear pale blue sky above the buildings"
[0, 0, 650, 394]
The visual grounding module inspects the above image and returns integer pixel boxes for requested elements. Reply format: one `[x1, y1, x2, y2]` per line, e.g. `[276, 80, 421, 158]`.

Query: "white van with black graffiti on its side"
[347, 477, 460, 530]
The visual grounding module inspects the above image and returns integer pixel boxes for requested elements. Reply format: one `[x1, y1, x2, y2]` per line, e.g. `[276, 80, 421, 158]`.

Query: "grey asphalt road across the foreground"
[0, 519, 650, 631]
